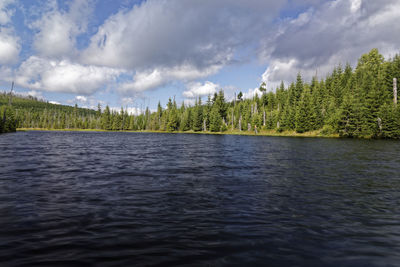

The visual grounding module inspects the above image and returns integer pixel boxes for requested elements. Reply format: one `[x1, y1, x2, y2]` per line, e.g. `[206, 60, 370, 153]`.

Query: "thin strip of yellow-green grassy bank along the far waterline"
[17, 128, 339, 138]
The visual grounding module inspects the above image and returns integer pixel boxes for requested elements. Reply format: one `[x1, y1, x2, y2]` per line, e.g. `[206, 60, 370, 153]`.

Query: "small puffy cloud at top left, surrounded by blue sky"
[31, 0, 91, 58]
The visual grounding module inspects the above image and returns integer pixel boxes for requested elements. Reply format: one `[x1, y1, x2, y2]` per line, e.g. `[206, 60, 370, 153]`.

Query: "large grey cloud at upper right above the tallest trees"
[261, 0, 400, 87]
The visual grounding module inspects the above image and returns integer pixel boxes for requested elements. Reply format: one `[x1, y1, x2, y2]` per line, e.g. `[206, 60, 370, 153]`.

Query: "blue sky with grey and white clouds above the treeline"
[0, 0, 400, 112]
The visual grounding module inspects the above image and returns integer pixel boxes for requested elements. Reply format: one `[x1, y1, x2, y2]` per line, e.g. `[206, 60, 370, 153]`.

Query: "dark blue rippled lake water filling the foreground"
[0, 132, 400, 266]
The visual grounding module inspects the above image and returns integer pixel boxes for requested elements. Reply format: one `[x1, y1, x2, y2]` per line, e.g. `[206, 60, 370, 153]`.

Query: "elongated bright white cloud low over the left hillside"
[15, 56, 120, 95]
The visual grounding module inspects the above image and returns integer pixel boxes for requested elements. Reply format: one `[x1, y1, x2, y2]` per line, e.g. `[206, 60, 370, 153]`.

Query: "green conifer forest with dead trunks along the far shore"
[0, 49, 400, 139]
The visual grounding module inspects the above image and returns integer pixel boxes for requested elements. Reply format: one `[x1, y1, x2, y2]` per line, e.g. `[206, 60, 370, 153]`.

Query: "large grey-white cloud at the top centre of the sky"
[83, 0, 284, 69]
